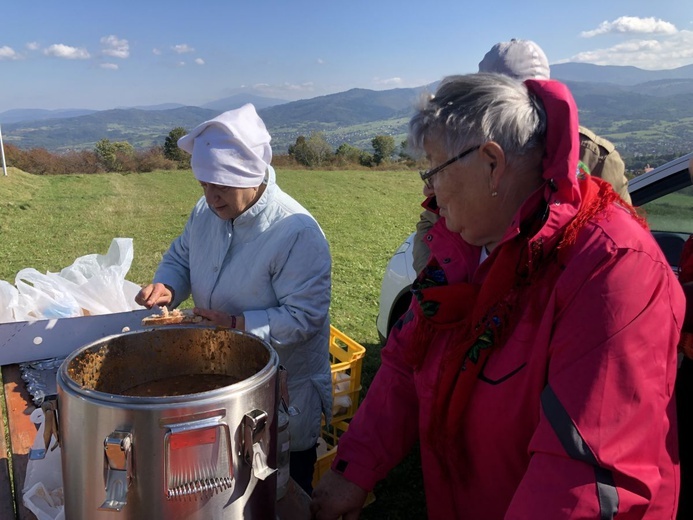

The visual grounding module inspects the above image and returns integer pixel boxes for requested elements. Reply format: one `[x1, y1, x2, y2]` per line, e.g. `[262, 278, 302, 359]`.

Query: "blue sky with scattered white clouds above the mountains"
[0, 0, 693, 112]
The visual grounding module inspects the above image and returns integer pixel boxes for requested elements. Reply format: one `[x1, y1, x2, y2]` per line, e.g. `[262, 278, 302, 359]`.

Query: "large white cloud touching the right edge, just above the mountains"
[561, 30, 693, 70]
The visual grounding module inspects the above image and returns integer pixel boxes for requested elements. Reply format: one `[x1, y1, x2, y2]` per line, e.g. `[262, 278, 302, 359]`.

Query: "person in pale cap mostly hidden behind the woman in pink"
[412, 39, 631, 273]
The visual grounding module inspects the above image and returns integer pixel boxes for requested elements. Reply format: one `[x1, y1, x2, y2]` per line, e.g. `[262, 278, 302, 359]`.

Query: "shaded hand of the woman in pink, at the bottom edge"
[310, 470, 368, 520]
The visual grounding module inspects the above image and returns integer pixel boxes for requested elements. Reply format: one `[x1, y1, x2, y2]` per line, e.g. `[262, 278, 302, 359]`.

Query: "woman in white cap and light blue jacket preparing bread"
[135, 104, 332, 493]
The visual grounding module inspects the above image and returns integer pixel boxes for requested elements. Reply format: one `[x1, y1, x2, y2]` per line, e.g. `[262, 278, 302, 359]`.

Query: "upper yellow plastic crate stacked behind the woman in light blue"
[330, 326, 366, 424]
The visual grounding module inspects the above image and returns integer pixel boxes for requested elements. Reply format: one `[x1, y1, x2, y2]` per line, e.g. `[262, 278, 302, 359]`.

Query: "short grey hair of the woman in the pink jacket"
[409, 74, 546, 166]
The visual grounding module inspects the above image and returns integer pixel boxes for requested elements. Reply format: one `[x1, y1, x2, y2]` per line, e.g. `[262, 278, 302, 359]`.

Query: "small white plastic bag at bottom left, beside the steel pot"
[22, 408, 65, 520]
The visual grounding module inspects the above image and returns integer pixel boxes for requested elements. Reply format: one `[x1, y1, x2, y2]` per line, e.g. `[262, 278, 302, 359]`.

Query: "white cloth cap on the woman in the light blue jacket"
[178, 103, 272, 188]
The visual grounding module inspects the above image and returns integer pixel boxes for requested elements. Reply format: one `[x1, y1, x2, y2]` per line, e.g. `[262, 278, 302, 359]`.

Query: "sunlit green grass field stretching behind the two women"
[0, 168, 425, 519]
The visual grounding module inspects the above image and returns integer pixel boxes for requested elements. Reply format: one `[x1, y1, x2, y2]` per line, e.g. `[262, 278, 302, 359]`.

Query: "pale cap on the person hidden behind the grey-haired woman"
[479, 38, 551, 81]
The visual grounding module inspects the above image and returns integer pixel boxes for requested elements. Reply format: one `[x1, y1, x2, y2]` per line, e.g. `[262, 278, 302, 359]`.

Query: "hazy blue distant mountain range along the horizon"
[0, 63, 693, 154]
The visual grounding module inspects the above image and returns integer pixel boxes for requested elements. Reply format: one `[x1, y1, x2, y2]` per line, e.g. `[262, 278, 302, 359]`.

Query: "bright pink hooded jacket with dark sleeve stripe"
[332, 81, 685, 520]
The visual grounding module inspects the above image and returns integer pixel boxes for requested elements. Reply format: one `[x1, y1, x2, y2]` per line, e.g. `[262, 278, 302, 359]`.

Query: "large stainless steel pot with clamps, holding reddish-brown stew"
[57, 325, 279, 520]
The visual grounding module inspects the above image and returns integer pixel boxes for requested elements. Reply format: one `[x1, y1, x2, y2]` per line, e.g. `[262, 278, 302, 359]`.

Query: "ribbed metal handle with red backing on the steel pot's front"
[164, 417, 233, 500]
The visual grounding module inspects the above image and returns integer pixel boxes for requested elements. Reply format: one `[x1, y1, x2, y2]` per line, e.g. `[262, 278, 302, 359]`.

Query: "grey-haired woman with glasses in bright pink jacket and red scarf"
[311, 74, 685, 520]
